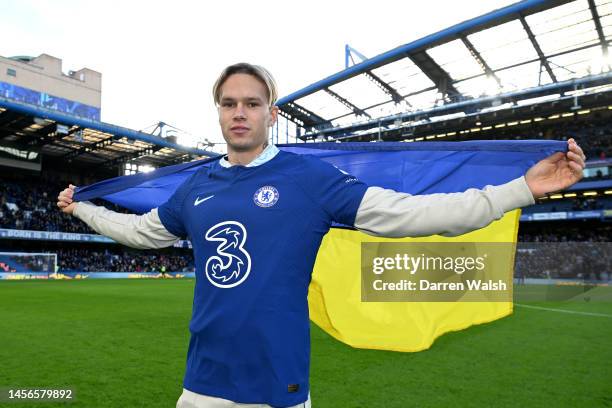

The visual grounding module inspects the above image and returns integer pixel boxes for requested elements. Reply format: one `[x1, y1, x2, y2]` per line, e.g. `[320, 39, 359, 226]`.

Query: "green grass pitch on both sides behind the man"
[0, 280, 612, 408]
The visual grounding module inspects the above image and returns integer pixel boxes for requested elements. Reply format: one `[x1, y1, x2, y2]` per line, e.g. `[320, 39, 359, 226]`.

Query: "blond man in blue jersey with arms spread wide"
[57, 63, 585, 407]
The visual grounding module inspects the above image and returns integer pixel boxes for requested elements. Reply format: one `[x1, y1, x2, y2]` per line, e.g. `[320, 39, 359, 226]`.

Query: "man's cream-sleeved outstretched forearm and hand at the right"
[355, 139, 585, 238]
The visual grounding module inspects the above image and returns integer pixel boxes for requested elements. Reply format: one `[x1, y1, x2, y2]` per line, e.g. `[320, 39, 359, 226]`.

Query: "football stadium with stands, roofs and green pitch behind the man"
[0, 0, 612, 408]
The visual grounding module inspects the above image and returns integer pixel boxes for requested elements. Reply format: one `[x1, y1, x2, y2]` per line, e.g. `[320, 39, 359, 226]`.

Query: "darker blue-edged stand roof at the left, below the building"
[0, 97, 217, 167]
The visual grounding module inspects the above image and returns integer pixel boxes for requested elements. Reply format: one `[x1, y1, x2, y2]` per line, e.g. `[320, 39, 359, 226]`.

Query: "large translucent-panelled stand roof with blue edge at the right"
[277, 0, 612, 140]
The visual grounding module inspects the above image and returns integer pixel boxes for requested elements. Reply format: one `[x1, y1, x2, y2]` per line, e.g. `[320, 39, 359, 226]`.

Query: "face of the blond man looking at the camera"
[219, 74, 278, 152]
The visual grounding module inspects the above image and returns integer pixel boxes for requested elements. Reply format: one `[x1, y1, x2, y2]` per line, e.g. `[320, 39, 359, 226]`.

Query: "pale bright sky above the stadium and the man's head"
[0, 0, 515, 152]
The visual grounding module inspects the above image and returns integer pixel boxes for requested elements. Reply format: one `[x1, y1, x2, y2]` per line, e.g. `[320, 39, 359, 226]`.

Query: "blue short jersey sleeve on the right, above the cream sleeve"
[306, 157, 368, 226]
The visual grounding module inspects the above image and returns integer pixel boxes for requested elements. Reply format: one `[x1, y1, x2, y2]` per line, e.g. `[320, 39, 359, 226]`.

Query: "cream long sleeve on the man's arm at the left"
[72, 201, 179, 249]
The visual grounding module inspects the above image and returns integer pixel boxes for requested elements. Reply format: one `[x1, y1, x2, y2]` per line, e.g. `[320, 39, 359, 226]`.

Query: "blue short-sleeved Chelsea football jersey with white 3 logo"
[159, 151, 367, 407]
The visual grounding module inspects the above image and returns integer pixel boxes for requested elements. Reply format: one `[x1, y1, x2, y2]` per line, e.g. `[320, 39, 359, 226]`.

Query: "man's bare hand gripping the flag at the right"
[525, 139, 586, 198]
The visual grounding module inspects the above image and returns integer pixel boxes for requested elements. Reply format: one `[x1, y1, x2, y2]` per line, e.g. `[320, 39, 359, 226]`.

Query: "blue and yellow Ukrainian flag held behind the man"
[75, 141, 567, 351]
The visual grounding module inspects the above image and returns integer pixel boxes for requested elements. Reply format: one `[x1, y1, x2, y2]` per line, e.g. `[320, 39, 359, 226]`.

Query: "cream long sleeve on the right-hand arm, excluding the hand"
[355, 177, 534, 238]
